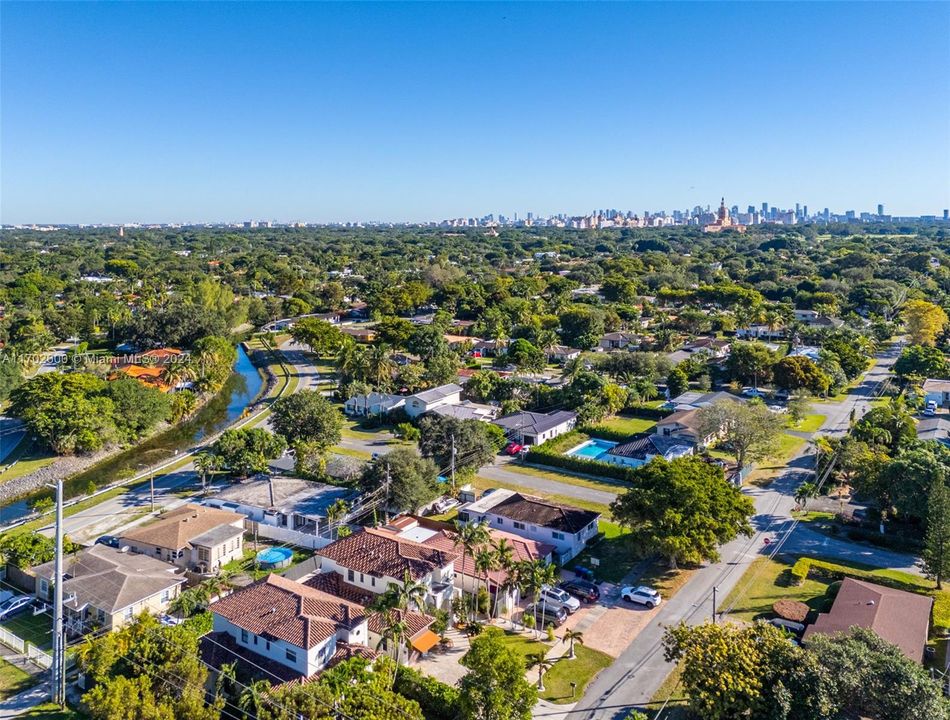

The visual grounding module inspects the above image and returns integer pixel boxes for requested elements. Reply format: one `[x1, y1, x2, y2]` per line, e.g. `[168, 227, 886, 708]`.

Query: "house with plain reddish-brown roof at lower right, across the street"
[803, 578, 933, 662]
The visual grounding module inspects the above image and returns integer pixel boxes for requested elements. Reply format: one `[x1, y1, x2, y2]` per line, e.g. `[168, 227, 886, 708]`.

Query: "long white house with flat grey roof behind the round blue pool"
[204, 475, 357, 548]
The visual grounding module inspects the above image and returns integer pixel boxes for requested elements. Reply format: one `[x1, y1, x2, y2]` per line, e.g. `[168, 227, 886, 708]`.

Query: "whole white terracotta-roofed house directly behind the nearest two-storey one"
[316, 528, 460, 608]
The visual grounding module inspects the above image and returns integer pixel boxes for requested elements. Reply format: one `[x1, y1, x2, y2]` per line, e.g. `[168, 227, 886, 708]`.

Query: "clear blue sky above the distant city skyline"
[0, 2, 950, 223]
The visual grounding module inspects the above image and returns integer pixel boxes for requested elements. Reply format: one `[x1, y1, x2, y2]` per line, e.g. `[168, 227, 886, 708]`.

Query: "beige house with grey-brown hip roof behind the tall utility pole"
[32, 545, 185, 635]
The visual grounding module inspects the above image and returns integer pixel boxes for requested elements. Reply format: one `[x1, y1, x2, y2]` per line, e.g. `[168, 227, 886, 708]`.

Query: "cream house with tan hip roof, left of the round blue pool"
[120, 503, 244, 573]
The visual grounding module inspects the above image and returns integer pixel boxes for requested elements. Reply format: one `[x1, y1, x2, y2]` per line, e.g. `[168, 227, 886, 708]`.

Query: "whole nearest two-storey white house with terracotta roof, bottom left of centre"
[202, 575, 370, 681]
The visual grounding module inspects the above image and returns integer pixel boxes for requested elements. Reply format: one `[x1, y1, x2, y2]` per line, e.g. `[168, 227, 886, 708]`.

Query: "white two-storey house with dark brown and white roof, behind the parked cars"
[458, 489, 600, 563]
